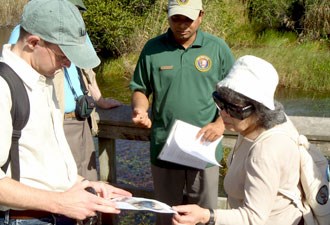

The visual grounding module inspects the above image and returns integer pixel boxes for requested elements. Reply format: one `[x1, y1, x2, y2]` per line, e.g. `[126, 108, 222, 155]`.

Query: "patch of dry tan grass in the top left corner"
[0, 0, 28, 27]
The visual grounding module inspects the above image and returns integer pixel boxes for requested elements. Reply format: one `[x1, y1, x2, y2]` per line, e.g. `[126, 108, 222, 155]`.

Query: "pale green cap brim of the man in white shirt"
[59, 43, 101, 69]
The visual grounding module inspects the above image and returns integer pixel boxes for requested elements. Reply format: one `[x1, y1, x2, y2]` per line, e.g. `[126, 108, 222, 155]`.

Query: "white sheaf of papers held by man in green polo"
[158, 120, 223, 169]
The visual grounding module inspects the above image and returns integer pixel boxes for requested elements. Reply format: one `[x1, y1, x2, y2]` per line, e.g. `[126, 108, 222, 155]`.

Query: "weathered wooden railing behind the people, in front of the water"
[97, 105, 330, 197]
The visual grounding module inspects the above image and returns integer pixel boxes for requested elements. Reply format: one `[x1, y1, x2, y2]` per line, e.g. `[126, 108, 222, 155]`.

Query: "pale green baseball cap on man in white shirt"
[20, 0, 101, 69]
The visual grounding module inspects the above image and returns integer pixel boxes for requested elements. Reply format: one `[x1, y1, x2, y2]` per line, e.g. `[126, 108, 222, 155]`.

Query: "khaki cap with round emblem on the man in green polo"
[167, 0, 203, 20]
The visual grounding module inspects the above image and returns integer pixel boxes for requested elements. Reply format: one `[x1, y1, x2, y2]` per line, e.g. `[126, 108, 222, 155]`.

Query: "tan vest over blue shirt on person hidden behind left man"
[53, 69, 98, 136]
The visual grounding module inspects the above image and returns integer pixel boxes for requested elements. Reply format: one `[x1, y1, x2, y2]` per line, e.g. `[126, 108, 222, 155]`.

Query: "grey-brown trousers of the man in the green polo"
[151, 165, 219, 225]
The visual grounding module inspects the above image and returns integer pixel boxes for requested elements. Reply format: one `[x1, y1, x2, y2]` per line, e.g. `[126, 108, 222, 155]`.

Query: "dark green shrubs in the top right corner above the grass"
[246, 0, 330, 40]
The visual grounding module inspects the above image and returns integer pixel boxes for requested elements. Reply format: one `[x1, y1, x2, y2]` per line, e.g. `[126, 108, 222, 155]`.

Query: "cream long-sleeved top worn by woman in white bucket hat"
[216, 122, 302, 225]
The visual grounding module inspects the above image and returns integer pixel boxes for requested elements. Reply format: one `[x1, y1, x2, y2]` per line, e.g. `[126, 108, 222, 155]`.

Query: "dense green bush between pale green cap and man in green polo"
[83, 0, 154, 57]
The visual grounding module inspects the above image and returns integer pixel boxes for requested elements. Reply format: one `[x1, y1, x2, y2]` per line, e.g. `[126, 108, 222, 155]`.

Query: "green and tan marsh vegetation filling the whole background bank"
[0, 0, 330, 96]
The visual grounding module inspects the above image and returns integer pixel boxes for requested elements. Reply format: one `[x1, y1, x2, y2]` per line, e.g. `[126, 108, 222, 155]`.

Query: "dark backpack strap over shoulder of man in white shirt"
[0, 62, 30, 181]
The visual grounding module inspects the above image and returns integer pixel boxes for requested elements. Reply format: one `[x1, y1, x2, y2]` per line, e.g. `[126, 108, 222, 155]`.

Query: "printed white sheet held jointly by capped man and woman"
[111, 197, 177, 213]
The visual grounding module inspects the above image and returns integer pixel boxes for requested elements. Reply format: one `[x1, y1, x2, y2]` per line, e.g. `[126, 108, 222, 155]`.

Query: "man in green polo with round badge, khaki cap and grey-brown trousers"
[130, 0, 234, 225]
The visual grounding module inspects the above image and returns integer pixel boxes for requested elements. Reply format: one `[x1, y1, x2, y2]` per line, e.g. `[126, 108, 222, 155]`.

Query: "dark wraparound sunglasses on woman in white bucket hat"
[212, 91, 255, 120]
